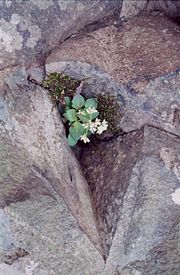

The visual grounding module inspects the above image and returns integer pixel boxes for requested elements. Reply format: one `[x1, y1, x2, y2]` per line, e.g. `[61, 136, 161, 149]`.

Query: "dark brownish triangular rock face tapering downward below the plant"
[80, 131, 142, 259]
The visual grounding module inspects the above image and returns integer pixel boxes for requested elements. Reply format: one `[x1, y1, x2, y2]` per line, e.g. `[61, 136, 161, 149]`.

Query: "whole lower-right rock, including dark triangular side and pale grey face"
[81, 127, 180, 275]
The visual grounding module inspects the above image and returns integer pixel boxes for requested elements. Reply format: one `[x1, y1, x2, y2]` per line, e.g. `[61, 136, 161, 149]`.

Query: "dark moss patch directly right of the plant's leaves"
[97, 94, 121, 135]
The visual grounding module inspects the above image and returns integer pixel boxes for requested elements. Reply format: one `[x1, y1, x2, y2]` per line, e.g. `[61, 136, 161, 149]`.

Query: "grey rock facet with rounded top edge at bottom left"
[0, 195, 104, 275]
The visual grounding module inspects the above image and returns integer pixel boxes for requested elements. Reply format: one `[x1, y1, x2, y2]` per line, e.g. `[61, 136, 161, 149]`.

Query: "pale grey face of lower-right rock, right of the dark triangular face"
[106, 127, 180, 275]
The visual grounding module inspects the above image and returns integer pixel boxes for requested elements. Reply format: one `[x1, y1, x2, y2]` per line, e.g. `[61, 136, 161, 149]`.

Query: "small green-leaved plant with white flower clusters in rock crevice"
[63, 95, 108, 146]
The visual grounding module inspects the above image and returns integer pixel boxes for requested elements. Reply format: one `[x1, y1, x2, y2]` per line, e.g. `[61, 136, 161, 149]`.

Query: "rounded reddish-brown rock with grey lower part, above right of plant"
[45, 12, 180, 138]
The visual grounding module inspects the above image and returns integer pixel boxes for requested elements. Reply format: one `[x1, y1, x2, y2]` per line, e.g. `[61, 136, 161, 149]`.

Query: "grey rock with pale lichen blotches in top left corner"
[0, 0, 122, 69]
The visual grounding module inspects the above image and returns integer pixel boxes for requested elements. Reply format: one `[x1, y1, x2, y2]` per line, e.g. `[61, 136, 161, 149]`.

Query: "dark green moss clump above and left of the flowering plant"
[42, 72, 80, 103]
